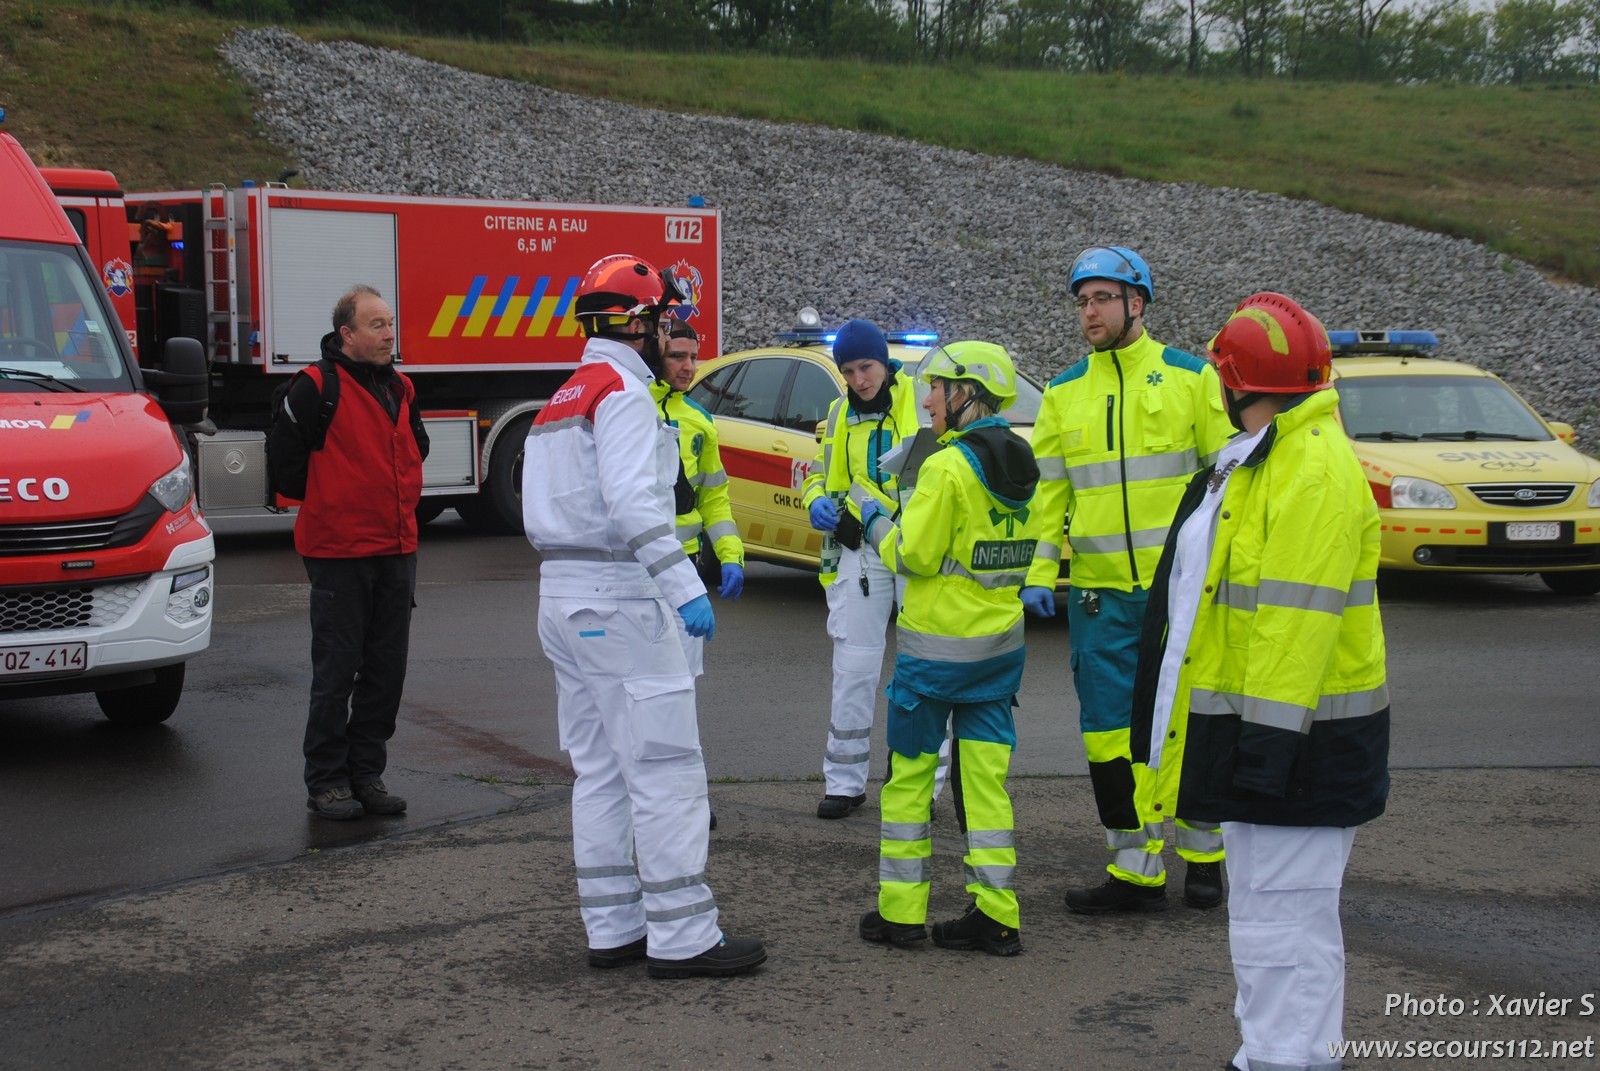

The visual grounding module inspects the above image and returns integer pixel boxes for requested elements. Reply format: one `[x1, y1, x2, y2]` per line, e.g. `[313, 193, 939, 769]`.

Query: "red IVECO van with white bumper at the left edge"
[0, 134, 214, 724]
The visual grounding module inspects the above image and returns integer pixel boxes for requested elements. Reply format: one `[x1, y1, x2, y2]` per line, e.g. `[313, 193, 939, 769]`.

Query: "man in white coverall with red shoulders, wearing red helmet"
[522, 255, 766, 978]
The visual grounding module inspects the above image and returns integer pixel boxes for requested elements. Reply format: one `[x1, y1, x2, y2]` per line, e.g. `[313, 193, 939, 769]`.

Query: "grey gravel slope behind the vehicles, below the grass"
[224, 30, 1600, 448]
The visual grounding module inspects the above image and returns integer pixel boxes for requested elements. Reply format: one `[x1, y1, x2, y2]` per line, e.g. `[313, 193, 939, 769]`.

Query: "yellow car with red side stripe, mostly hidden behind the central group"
[688, 314, 1042, 568]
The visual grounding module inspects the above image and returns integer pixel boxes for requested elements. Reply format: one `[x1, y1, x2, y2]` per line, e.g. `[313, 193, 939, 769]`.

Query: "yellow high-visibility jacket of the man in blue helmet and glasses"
[1027, 333, 1234, 591]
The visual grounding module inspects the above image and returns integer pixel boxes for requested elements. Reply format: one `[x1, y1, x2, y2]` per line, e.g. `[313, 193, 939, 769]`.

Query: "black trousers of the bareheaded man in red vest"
[302, 554, 416, 796]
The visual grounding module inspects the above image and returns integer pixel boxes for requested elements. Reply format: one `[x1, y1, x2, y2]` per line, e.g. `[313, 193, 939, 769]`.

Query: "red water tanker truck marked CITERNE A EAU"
[45, 170, 722, 531]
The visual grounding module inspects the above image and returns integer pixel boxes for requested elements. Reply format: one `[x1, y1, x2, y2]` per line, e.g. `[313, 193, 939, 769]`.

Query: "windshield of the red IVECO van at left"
[0, 242, 133, 392]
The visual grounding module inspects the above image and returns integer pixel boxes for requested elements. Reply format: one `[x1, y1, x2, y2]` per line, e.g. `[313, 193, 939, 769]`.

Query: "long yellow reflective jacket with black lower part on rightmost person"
[1131, 389, 1389, 826]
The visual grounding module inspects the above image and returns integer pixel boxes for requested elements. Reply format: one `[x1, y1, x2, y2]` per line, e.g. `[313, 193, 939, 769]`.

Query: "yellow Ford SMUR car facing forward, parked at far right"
[1328, 331, 1600, 596]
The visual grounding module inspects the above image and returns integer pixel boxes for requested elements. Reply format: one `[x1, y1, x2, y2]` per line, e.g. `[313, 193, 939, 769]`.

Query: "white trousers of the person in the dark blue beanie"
[822, 544, 950, 799]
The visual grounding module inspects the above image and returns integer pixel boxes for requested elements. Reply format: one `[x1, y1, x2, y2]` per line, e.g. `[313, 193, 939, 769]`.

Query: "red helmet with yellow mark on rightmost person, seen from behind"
[1208, 291, 1333, 394]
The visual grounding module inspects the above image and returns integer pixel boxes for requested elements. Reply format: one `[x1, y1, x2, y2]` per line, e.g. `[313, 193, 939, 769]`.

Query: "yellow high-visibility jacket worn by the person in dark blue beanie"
[800, 368, 917, 588]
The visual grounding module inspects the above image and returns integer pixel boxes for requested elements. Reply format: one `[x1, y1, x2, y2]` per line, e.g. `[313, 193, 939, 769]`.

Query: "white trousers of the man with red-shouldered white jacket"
[539, 596, 722, 959]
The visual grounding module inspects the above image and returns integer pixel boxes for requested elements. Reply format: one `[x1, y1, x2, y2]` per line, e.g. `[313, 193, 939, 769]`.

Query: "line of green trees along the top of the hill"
[150, 0, 1600, 85]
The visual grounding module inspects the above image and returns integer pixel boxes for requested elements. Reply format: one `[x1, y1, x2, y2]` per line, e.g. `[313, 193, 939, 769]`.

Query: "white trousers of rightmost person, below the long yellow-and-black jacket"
[1222, 821, 1355, 1071]
